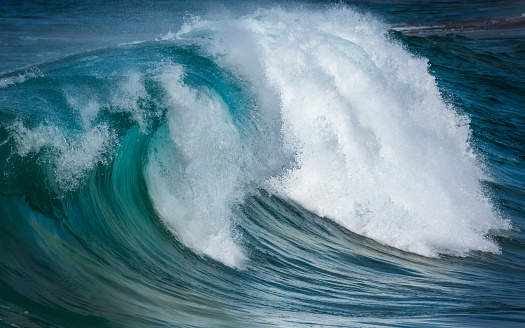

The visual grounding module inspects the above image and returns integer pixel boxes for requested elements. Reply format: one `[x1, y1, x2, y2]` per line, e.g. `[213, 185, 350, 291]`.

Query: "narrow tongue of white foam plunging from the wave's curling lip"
[145, 65, 245, 267]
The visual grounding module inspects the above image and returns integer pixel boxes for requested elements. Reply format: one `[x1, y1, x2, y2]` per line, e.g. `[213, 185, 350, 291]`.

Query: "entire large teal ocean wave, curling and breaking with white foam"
[0, 6, 511, 326]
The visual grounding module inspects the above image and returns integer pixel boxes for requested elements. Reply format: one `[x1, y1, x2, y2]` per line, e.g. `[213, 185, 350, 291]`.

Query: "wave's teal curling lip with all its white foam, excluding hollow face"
[3, 8, 510, 267]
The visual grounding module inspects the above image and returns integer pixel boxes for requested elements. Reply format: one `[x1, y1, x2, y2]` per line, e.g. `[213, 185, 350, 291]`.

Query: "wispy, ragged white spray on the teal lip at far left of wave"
[10, 72, 159, 191]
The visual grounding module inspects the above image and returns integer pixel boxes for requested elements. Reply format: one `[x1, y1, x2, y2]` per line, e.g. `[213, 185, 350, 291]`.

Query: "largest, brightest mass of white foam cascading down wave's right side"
[175, 7, 509, 256]
